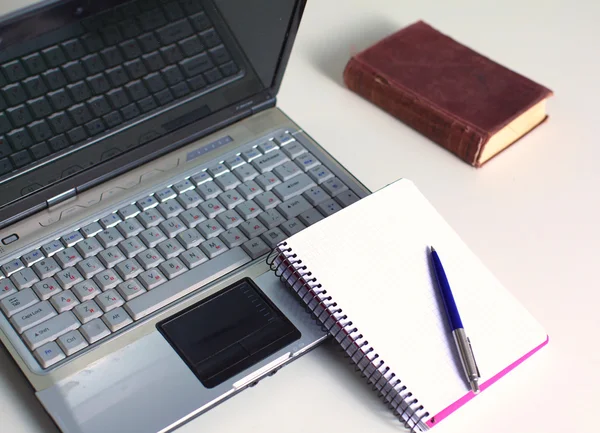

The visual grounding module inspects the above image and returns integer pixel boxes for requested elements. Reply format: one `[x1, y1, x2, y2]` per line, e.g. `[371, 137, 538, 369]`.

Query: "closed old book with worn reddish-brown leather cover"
[344, 21, 552, 167]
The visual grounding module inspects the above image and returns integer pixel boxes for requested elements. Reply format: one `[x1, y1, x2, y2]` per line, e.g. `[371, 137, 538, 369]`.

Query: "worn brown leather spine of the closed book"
[344, 57, 490, 167]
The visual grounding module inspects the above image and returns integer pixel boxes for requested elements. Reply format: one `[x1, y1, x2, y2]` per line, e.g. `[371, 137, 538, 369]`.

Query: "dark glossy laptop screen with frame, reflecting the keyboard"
[0, 0, 304, 227]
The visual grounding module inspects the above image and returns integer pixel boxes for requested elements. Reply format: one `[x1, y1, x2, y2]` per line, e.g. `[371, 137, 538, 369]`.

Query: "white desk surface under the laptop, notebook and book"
[0, 0, 600, 433]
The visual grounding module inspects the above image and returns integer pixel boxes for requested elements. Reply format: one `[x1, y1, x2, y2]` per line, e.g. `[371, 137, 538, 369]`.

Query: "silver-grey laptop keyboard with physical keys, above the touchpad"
[0, 132, 359, 368]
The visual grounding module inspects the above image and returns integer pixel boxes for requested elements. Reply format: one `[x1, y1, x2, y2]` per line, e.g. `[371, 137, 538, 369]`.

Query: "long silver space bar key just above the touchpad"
[125, 247, 252, 320]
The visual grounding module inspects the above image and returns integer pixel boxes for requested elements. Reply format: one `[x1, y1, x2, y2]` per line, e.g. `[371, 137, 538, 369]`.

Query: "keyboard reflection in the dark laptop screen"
[0, 0, 239, 176]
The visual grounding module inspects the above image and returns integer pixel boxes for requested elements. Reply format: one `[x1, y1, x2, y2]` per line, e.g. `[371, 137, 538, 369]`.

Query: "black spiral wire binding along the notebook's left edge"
[267, 241, 429, 433]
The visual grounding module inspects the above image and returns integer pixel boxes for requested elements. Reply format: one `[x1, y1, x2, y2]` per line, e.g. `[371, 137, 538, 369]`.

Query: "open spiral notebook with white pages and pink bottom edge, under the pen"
[267, 179, 548, 431]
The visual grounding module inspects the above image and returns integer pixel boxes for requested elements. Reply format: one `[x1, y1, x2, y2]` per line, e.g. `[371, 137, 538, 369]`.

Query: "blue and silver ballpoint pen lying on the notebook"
[430, 247, 481, 394]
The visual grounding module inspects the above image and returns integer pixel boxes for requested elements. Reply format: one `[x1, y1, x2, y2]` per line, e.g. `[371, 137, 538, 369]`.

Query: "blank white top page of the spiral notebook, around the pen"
[288, 180, 546, 415]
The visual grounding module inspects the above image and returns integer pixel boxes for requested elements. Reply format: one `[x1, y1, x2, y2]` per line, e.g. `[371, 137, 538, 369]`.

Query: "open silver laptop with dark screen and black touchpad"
[0, 0, 369, 433]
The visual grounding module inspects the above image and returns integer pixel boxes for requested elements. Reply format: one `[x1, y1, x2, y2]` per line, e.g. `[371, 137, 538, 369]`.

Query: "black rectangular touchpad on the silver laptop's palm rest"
[157, 278, 300, 388]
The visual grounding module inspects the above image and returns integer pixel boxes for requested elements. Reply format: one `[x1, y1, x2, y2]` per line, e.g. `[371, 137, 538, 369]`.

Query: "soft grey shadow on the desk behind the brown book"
[313, 17, 403, 87]
